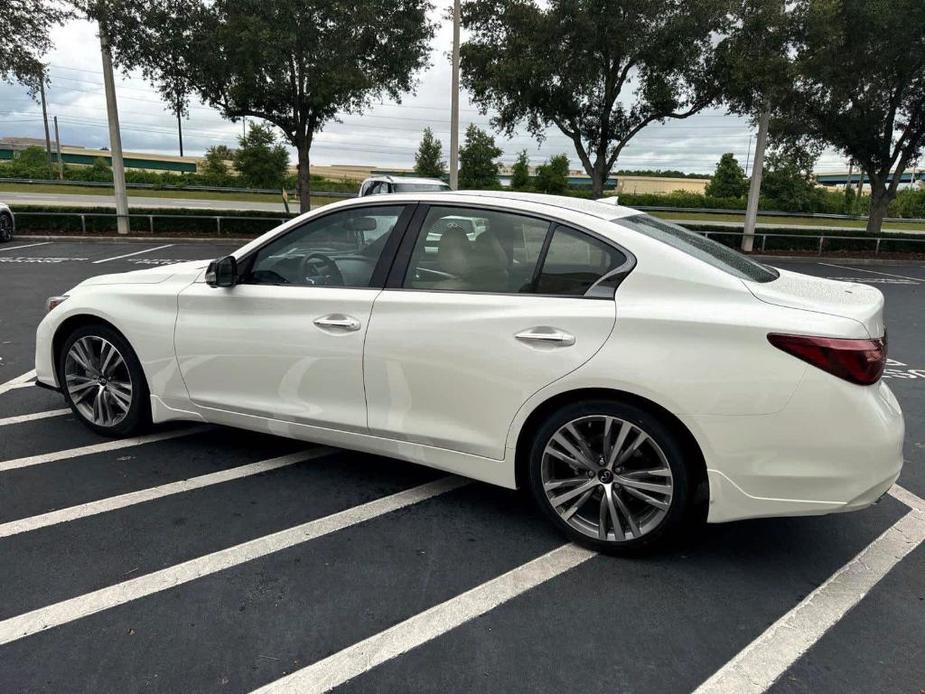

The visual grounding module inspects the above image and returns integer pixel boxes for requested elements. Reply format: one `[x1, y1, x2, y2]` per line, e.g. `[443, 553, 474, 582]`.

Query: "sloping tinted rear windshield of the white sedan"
[610, 214, 780, 282]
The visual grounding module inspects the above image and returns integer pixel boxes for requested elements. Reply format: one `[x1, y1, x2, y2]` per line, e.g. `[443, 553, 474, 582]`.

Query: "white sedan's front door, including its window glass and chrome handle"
[175, 203, 413, 431]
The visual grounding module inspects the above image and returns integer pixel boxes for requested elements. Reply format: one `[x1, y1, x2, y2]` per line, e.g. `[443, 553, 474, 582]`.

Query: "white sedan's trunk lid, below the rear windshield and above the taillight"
[744, 270, 884, 337]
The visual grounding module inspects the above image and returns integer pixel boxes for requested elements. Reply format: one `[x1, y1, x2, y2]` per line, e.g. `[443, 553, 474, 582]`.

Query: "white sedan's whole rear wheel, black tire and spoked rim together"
[529, 400, 694, 554]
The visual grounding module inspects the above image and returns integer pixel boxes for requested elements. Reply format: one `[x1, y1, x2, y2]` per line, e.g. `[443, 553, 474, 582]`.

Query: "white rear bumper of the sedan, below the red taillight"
[682, 376, 904, 523]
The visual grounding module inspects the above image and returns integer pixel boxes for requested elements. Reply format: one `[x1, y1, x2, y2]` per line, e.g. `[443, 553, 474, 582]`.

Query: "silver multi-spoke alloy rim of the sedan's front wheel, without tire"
[64, 335, 133, 427]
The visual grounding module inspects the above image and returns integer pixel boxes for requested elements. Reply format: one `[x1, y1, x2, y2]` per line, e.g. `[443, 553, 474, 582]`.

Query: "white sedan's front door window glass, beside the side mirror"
[244, 205, 405, 287]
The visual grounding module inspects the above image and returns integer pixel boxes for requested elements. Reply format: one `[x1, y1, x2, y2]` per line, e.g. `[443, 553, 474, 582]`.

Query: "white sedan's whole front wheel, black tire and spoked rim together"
[57, 324, 151, 438]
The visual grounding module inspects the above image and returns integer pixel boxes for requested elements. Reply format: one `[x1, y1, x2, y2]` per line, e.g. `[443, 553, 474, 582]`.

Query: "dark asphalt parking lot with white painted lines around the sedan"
[0, 239, 925, 694]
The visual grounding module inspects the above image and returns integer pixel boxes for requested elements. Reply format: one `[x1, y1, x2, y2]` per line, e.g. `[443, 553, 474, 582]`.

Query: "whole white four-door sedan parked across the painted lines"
[36, 192, 903, 552]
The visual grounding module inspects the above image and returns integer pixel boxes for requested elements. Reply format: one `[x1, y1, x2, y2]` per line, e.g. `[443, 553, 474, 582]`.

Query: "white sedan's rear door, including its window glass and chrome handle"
[364, 206, 628, 459]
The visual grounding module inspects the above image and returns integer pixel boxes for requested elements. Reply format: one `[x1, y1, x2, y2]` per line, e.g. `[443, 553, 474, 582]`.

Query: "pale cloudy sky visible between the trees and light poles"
[0, 0, 846, 177]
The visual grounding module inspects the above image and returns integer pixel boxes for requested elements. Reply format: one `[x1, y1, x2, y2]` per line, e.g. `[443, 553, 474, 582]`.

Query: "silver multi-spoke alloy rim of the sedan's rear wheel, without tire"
[540, 415, 674, 542]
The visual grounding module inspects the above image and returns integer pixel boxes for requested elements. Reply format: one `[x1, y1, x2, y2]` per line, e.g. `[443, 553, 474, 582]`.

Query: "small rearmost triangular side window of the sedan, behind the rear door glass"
[536, 226, 626, 296]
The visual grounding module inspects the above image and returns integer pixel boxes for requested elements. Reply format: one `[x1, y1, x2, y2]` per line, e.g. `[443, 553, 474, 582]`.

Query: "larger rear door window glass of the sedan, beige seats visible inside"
[404, 207, 550, 294]
